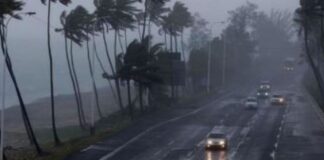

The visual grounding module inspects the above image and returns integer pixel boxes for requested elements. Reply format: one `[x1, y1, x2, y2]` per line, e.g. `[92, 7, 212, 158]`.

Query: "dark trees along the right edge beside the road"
[295, 0, 324, 109]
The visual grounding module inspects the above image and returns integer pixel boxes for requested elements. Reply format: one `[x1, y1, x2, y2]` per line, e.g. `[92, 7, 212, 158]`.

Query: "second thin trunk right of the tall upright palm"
[70, 40, 87, 125]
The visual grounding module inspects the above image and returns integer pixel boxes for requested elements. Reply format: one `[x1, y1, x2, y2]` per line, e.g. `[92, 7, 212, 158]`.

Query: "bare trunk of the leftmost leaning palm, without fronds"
[0, 24, 43, 155]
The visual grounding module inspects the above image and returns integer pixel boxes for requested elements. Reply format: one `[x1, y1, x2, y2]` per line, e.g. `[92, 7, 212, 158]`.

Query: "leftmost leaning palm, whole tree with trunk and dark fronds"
[0, 0, 43, 156]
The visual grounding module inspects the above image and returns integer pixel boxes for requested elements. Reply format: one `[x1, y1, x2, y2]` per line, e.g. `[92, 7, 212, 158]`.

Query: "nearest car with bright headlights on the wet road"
[205, 133, 228, 150]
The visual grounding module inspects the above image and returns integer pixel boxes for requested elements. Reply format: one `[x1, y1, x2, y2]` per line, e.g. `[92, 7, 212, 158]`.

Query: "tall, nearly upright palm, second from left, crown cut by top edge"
[41, 0, 71, 145]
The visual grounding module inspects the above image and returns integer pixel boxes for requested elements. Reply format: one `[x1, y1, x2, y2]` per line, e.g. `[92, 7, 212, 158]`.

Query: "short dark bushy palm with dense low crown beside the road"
[117, 36, 162, 114]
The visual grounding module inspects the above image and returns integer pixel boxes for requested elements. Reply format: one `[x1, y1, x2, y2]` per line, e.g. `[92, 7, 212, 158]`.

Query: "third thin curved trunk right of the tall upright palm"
[87, 36, 103, 119]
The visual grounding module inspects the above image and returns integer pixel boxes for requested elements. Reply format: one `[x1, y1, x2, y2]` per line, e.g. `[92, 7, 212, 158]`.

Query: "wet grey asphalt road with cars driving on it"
[68, 71, 324, 160]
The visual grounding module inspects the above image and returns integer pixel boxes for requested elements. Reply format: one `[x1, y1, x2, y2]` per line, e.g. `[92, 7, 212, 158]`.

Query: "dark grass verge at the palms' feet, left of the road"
[6, 112, 131, 160]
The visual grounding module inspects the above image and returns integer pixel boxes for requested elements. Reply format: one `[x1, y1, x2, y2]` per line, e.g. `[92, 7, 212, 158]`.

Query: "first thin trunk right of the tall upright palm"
[64, 33, 85, 129]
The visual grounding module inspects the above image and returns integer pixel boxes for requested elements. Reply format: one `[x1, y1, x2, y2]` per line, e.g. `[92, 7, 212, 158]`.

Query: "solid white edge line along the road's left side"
[99, 92, 232, 160]
